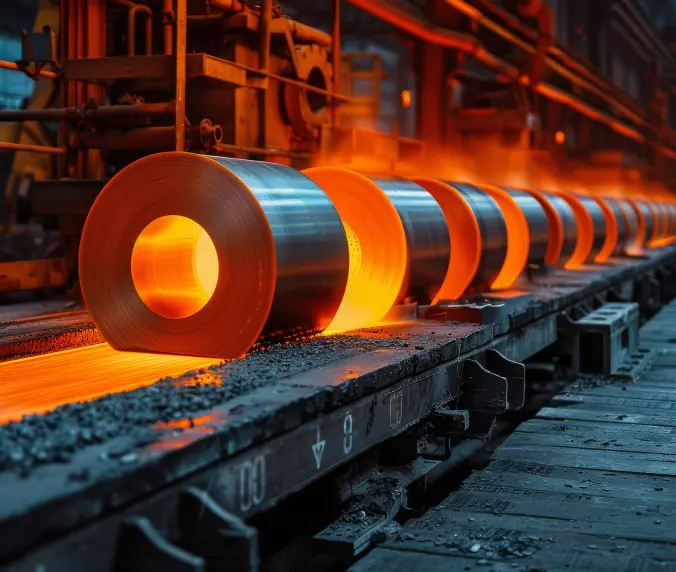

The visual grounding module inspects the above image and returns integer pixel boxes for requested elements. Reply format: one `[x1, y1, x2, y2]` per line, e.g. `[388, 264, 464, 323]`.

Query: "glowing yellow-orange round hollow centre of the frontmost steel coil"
[131, 215, 218, 318]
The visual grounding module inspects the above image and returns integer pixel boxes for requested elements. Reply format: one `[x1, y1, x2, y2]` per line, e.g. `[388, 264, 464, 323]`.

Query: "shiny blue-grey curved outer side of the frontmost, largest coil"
[214, 157, 349, 335]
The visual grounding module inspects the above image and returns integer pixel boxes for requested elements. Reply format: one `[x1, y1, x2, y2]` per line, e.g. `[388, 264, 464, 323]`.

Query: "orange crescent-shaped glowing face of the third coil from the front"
[412, 177, 481, 302]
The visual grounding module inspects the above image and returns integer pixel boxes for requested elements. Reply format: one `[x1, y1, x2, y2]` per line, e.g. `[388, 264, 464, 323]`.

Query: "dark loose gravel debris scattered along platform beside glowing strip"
[0, 328, 433, 476]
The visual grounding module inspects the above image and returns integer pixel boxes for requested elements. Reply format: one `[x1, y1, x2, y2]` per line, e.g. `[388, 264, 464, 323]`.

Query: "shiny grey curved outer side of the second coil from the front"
[369, 175, 452, 304]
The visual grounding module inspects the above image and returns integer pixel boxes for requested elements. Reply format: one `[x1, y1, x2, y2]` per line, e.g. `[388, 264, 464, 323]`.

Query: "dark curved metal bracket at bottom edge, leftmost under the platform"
[114, 517, 207, 572]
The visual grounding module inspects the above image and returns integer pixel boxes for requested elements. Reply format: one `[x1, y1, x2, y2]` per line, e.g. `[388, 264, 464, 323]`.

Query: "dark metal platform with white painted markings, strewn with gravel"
[0, 249, 676, 572]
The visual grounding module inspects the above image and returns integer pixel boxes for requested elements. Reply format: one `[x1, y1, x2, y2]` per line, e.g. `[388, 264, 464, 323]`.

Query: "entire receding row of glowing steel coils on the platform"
[79, 153, 676, 359]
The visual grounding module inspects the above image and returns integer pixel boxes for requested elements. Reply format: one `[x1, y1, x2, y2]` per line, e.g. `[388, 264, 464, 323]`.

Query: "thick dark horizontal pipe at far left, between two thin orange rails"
[0, 102, 174, 121]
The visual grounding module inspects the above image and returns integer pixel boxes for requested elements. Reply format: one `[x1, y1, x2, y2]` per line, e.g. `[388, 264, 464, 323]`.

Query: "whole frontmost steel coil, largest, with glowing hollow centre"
[79, 152, 349, 358]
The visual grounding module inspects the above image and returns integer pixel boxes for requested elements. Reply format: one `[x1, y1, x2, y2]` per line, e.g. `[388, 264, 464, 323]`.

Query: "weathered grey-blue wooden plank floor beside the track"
[350, 302, 676, 572]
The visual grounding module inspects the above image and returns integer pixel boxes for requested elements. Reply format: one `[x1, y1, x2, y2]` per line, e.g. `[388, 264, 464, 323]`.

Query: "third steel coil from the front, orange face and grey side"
[413, 177, 507, 300]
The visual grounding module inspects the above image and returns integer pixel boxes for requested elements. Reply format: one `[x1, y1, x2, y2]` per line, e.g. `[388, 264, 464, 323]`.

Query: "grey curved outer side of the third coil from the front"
[448, 182, 507, 292]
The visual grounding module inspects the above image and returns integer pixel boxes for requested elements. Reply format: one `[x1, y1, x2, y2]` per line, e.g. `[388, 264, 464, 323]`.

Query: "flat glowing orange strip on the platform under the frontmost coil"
[0, 344, 220, 423]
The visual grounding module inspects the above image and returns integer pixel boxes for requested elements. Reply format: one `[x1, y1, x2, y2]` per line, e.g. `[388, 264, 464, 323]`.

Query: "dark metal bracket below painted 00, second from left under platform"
[178, 488, 259, 572]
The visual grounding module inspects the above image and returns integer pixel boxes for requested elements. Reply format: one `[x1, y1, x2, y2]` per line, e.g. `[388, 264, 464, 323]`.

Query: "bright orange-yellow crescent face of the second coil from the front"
[303, 167, 408, 333]
